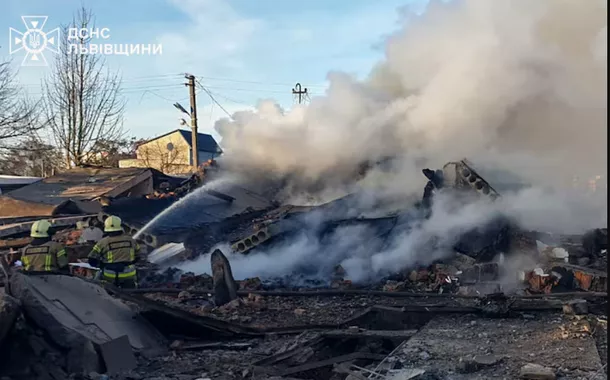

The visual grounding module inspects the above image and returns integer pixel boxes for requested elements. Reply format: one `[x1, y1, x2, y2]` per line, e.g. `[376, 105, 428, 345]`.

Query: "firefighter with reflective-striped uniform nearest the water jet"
[89, 216, 140, 288]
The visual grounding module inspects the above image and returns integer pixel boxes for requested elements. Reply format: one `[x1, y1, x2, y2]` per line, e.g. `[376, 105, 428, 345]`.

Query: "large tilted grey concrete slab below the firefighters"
[11, 273, 164, 352]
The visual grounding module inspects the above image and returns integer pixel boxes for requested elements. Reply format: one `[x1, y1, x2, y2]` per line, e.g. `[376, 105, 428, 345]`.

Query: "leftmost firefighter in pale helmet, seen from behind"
[21, 220, 68, 272]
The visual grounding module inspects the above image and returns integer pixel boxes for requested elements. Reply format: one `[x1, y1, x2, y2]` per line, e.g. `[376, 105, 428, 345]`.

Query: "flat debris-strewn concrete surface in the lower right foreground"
[382, 315, 601, 380]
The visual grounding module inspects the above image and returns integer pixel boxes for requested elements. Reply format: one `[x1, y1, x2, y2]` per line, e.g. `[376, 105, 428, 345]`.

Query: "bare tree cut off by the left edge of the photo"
[0, 61, 42, 152]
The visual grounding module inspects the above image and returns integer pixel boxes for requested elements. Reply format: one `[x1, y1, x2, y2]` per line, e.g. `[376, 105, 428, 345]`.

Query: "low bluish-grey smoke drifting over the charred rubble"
[181, 184, 593, 283]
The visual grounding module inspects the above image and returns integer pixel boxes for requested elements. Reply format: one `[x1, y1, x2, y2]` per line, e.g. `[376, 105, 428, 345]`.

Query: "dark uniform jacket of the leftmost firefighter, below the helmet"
[21, 240, 68, 272]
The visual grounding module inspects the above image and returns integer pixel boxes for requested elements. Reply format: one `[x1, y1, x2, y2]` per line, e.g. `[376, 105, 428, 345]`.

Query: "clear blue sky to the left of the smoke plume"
[0, 0, 425, 142]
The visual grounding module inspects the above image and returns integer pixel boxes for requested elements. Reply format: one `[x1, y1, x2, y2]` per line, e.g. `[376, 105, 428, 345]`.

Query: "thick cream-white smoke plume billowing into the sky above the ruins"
[216, 0, 607, 205]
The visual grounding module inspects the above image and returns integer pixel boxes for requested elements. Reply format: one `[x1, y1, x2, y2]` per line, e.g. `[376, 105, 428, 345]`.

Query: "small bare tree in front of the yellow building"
[138, 141, 190, 174]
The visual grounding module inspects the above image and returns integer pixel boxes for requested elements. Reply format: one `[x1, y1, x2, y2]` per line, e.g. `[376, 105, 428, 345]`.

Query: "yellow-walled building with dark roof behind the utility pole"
[119, 129, 222, 174]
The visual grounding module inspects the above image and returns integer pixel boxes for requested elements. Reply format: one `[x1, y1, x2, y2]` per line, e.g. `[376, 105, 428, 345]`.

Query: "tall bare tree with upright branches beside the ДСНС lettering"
[43, 8, 125, 166]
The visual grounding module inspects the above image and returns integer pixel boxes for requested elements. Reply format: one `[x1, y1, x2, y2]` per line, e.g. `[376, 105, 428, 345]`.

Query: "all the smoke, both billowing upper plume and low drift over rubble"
[177, 0, 607, 281]
